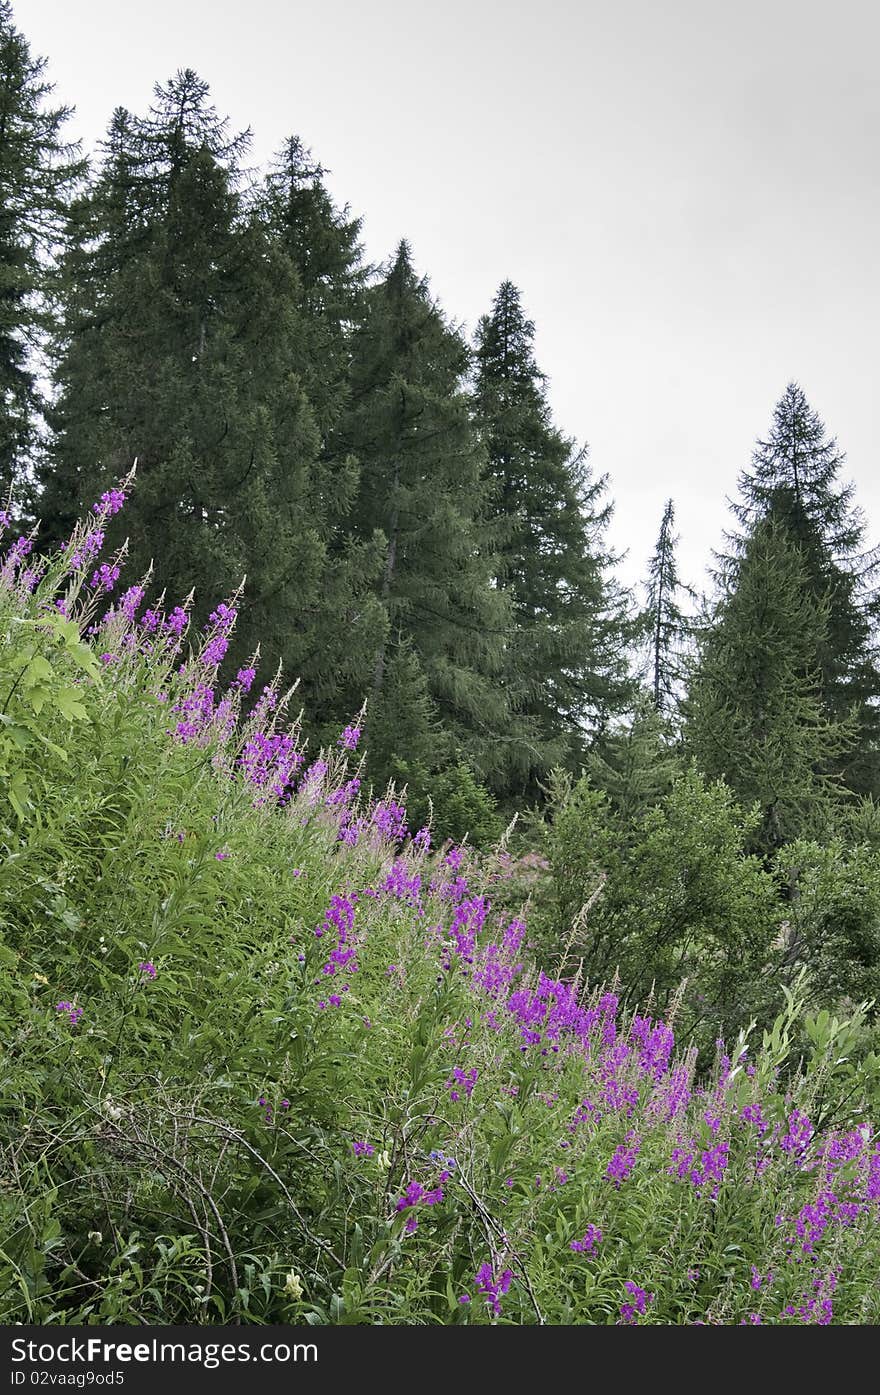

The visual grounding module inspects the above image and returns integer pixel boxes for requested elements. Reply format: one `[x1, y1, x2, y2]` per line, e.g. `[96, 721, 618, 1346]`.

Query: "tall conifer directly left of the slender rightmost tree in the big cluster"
[336, 243, 510, 776]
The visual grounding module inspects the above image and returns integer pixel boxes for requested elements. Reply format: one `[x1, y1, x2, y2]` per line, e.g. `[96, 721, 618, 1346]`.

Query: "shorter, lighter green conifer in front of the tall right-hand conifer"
[685, 516, 855, 852]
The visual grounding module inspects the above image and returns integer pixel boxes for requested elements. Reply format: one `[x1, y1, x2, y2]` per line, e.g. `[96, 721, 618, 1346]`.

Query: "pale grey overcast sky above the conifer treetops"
[13, 0, 880, 586]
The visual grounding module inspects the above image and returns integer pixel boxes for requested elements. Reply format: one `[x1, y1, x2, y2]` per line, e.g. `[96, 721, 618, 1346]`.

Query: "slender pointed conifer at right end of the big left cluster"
[474, 280, 632, 797]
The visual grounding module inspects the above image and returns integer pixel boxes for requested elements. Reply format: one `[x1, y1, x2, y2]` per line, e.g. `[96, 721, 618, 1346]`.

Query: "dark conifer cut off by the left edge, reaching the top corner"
[0, 0, 85, 513]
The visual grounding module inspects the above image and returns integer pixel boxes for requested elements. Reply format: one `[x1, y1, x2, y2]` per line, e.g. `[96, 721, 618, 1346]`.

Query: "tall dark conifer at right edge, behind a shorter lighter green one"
[728, 382, 880, 795]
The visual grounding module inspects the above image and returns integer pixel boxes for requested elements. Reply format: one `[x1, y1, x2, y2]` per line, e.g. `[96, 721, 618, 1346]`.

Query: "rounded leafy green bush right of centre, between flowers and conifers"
[533, 770, 781, 1041]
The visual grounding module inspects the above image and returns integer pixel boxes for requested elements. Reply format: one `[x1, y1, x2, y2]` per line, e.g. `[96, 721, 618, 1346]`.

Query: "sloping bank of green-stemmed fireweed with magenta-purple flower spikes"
[0, 480, 880, 1327]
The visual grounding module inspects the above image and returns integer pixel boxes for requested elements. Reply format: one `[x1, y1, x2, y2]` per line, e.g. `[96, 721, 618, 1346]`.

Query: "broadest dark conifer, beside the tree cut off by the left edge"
[45, 70, 381, 707]
